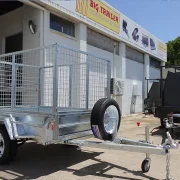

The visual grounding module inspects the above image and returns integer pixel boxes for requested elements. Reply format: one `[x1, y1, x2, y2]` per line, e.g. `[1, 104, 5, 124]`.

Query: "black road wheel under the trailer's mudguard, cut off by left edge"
[0, 126, 17, 164]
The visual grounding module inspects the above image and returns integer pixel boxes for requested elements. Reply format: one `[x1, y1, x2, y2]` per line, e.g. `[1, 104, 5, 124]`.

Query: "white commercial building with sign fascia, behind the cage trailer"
[0, 0, 167, 114]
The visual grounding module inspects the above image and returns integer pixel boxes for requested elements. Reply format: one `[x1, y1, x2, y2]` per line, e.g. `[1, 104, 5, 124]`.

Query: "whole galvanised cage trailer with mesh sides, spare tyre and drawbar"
[0, 44, 178, 180]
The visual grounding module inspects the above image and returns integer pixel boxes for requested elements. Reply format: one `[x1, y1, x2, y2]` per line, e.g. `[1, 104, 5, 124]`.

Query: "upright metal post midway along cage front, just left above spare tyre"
[86, 54, 90, 109]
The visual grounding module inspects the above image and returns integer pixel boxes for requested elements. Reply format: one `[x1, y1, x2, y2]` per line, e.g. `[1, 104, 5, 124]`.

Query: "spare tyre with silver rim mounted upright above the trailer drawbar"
[91, 98, 121, 141]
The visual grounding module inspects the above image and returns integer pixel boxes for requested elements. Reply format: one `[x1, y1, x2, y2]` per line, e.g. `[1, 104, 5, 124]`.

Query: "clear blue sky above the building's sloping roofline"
[105, 0, 180, 43]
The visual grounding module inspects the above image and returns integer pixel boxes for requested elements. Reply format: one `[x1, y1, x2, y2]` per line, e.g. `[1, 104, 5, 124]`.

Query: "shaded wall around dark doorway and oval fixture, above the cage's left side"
[0, 5, 42, 54]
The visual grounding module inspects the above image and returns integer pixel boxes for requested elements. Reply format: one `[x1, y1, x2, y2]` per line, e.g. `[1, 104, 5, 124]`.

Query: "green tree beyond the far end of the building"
[167, 37, 180, 65]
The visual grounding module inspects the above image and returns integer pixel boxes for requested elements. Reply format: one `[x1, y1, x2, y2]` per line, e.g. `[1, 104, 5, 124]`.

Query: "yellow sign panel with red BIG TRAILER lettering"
[76, 0, 120, 34]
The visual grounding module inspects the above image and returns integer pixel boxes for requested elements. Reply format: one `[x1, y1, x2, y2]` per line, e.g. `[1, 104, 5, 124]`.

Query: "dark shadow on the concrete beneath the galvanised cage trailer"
[0, 143, 158, 180]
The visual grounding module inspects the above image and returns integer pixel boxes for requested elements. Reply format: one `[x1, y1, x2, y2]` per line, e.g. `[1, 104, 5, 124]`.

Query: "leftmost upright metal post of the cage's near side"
[11, 55, 16, 109]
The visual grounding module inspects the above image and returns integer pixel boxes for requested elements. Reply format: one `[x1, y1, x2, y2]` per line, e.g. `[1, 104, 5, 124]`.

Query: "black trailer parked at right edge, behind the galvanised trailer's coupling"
[145, 66, 180, 127]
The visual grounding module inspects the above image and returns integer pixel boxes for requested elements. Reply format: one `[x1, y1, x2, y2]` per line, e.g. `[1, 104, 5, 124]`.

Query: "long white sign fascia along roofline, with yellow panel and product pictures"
[52, 0, 167, 61]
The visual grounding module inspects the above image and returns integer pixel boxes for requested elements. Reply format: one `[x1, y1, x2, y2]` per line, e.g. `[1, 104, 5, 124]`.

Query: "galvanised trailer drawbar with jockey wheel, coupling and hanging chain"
[64, 126, 179, 180]
